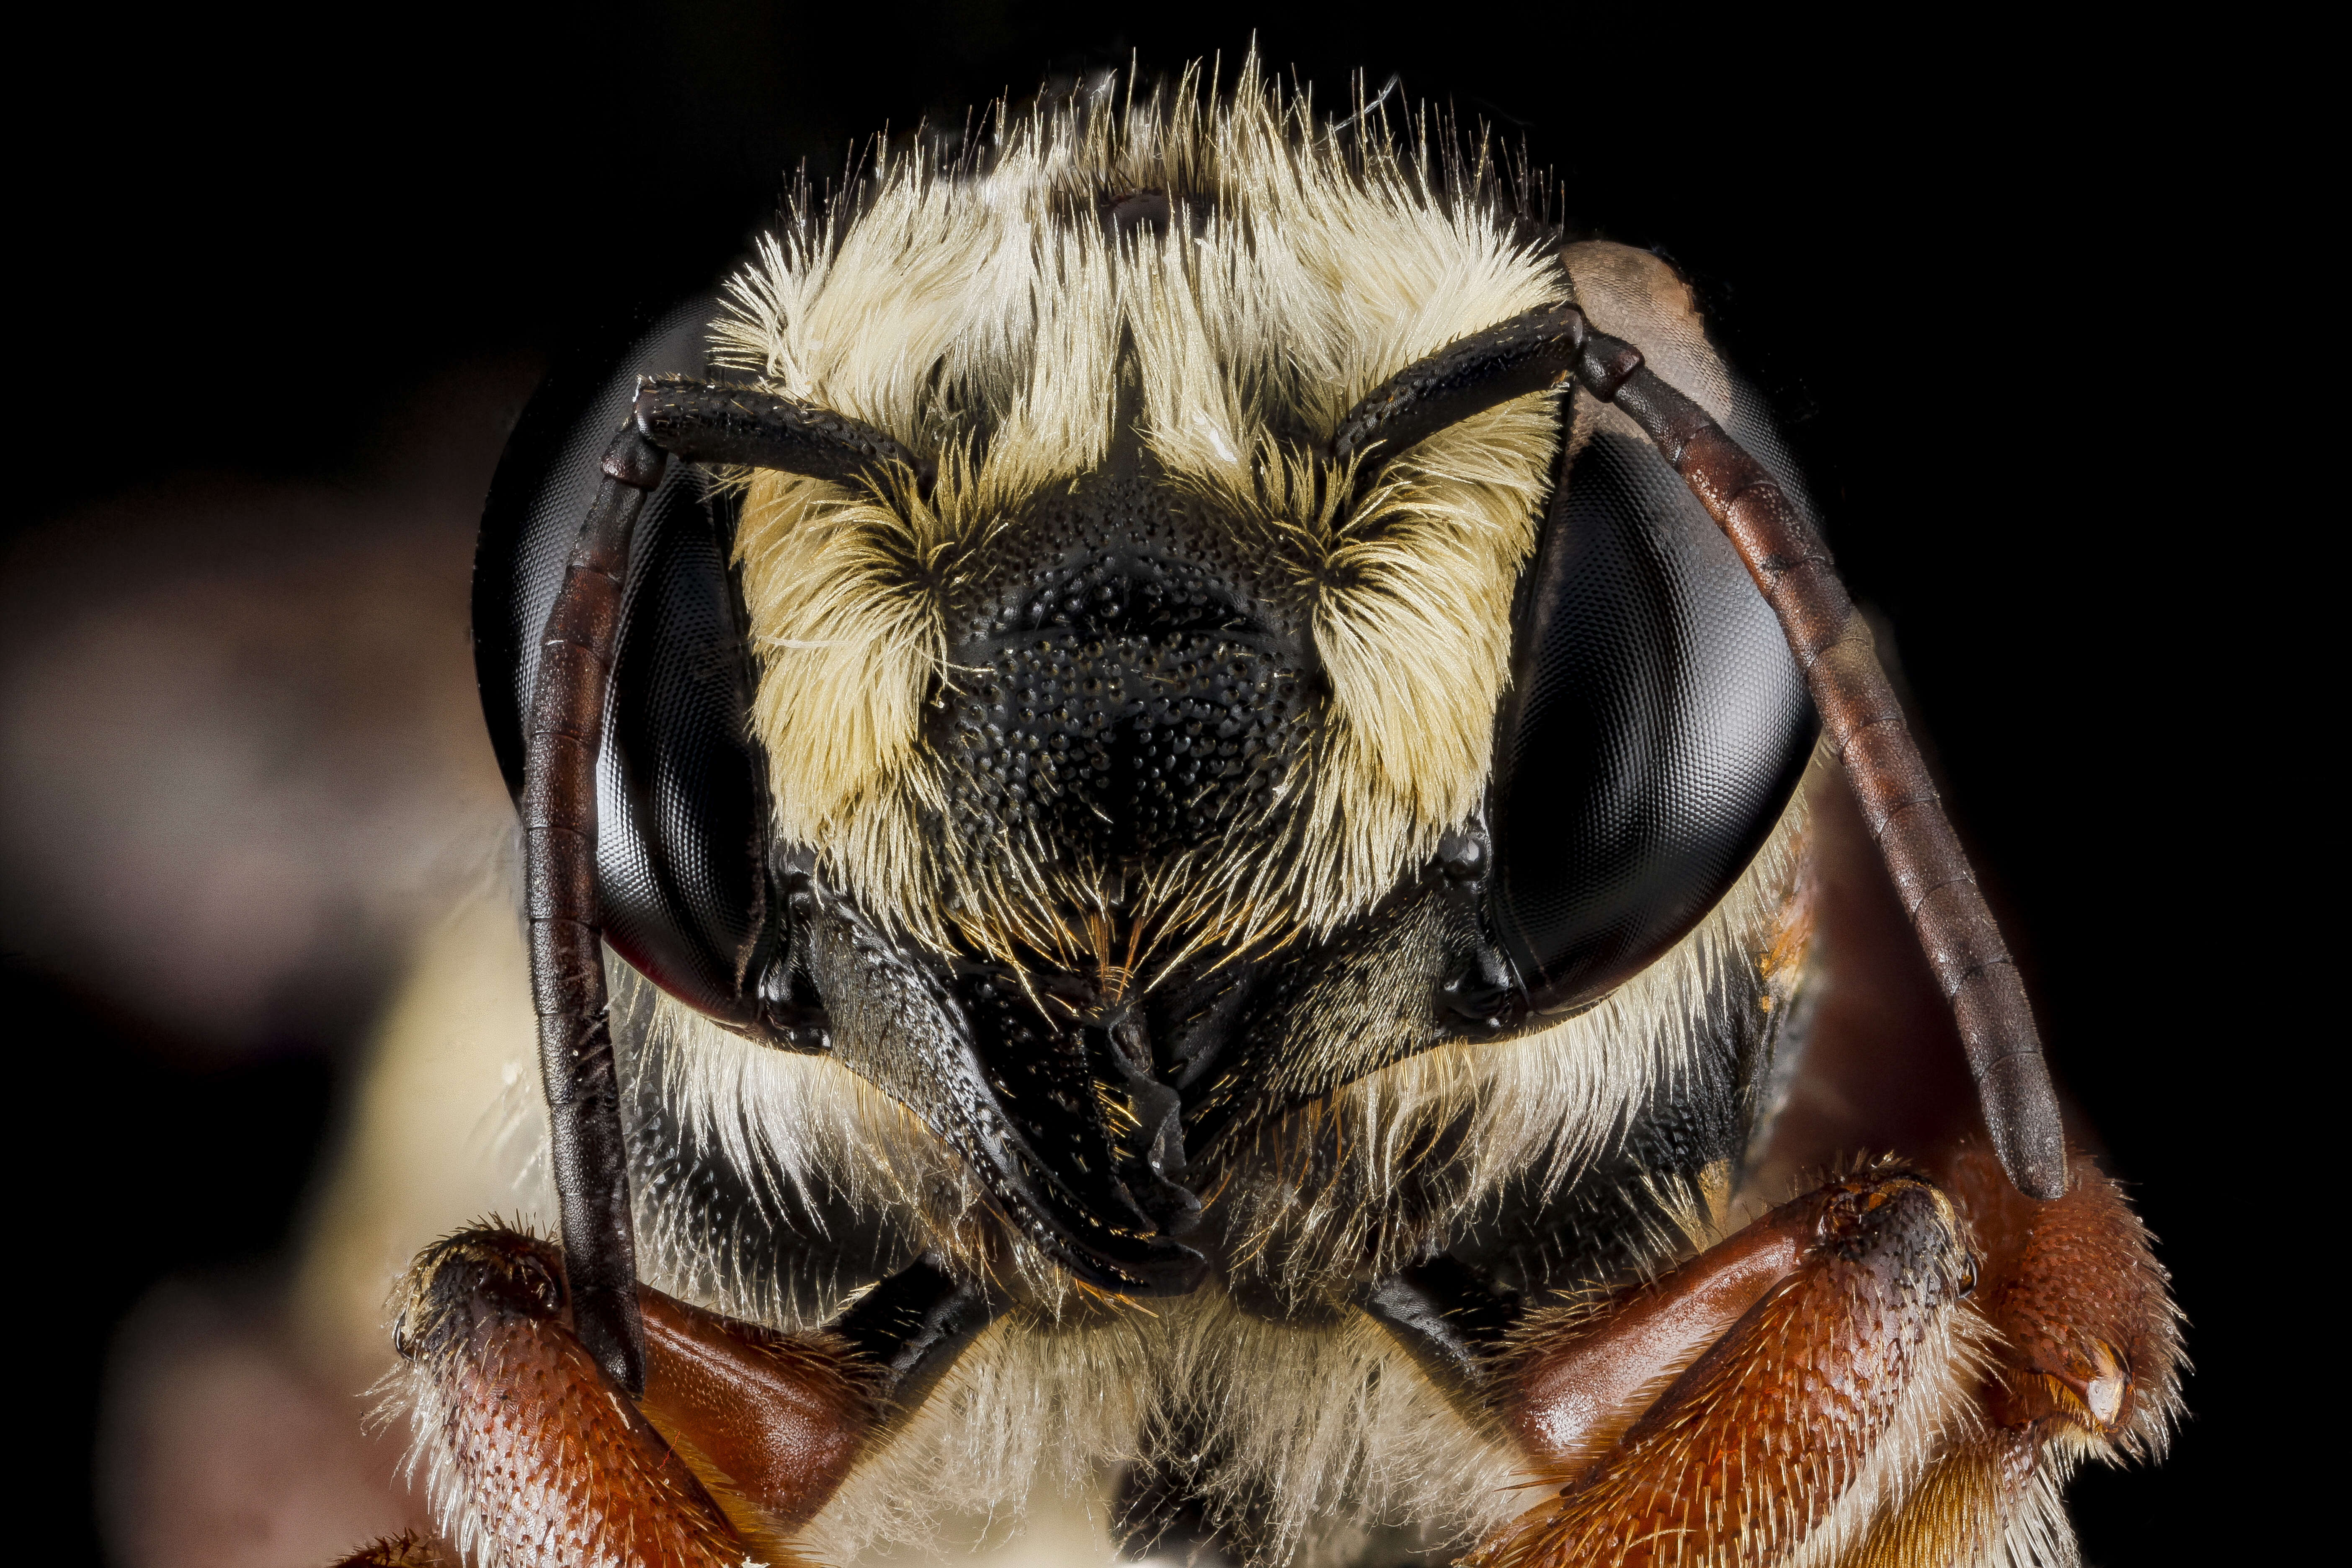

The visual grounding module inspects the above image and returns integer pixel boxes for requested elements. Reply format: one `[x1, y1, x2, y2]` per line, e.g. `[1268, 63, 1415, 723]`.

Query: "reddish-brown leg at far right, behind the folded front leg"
[1750, 774, 2180, 1568]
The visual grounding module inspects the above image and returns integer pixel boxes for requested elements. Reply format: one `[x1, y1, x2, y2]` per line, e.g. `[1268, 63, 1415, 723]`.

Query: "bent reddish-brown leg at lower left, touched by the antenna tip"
[390, 1232, 873, 1568]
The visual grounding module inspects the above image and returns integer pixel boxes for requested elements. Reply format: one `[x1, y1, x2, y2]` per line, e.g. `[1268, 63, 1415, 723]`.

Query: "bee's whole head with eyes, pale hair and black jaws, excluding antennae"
[477, 67, 1813, 1293]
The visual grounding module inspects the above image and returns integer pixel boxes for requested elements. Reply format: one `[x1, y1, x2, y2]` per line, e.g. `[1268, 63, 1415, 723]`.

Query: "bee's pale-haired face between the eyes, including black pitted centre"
[722, 160, 1562, 987]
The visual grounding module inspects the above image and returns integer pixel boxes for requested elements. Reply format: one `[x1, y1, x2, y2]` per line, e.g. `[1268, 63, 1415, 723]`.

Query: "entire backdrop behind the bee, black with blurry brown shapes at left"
[0, 0, 2267, 1568]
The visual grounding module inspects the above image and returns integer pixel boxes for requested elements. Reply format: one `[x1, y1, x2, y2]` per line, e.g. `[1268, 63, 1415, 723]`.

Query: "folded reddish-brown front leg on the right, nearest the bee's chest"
[1473, 1168, 1981, 1568]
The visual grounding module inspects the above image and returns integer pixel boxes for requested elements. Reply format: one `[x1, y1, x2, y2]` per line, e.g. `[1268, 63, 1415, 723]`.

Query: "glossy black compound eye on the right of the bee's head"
[1489, 395, 1816, 1013]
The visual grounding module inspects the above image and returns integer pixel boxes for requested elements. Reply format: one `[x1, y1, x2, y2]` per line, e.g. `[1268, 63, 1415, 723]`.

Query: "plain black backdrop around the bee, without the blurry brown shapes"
[0, 3, 2267, 1563]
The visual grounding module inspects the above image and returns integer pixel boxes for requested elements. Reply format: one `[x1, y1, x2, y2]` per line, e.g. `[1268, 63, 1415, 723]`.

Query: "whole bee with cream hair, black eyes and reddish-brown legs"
[351, 59, 2180, 1568]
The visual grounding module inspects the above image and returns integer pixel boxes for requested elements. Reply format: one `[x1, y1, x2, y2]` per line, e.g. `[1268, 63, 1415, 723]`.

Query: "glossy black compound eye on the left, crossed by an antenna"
[473, 299, 774, 1027]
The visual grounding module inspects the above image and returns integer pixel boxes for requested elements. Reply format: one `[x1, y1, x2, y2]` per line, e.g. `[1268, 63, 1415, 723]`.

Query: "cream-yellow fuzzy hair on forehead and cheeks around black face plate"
[715, 59, 1566, 952]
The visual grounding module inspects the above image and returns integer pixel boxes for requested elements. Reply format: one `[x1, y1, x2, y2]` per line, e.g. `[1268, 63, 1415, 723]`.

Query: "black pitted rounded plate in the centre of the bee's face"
[760, 423, 1331, 975]
